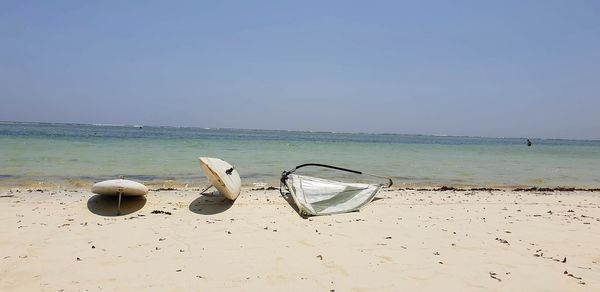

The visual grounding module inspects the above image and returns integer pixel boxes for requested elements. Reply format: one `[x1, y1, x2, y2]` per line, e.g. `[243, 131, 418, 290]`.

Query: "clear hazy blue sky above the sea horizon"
[0, 0, 600, 139]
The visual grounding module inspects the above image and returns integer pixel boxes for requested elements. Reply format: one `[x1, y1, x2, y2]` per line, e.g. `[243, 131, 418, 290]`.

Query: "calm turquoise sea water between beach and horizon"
[0, 122, 600, 187]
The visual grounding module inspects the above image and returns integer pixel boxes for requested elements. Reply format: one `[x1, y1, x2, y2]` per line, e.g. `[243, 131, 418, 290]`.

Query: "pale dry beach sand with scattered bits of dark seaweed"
[0, 189, 600, 291]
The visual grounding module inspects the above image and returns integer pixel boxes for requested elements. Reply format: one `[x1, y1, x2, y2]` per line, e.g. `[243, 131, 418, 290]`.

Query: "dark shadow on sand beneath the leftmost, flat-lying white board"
[88, 195, 146, 216]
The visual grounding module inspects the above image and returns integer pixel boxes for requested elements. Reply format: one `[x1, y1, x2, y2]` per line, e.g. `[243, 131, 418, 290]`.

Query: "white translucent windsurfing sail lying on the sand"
[285, 174, 382, 215]
